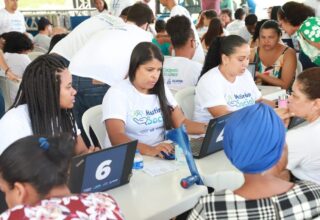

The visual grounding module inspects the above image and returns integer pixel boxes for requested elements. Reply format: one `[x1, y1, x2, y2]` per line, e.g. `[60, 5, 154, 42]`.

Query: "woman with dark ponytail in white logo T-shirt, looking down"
[193, 35, 261, 122]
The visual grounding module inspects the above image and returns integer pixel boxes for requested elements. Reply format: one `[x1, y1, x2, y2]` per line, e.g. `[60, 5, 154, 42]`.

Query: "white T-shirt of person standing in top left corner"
[0, 8, 26, 34]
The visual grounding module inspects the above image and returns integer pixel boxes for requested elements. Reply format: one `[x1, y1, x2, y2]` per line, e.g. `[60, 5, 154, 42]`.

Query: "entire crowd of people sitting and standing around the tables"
[0, 0, 320, 219]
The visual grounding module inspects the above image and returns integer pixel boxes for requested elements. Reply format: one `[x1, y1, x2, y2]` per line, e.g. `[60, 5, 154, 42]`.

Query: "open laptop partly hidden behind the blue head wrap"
[190, 113, 232, 159]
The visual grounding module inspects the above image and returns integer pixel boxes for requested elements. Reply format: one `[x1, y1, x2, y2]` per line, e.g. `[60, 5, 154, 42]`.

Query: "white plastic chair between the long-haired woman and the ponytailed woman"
[175, 86, 195, 119]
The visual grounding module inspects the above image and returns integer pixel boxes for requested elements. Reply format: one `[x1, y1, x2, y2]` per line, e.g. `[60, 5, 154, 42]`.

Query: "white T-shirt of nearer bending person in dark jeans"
[69, 24, 152, 85]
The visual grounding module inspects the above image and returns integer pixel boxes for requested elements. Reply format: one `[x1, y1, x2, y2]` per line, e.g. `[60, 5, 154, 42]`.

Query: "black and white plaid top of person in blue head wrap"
[188, 181, 320, 220]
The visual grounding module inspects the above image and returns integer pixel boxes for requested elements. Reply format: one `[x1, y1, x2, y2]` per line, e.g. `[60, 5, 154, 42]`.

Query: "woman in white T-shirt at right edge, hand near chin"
[281, 67, 320, 184]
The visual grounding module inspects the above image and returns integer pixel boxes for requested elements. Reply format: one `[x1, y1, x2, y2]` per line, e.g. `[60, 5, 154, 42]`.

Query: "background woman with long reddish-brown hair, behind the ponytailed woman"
[201, 18, 223, 53]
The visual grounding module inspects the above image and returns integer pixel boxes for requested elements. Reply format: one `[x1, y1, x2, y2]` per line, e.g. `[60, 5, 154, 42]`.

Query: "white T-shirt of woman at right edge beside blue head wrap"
[286, 118, 320, 184]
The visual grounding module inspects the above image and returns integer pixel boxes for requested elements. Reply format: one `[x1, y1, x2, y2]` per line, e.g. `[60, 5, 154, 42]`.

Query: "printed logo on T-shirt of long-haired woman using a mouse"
[133, 108, 163, 125]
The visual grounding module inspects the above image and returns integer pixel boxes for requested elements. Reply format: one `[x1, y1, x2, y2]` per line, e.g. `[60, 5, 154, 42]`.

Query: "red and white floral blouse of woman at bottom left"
[0, 193, 124, 220]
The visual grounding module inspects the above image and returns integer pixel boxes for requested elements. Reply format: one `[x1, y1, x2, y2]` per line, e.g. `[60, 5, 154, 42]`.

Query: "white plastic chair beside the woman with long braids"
[82, 105, 112, 148]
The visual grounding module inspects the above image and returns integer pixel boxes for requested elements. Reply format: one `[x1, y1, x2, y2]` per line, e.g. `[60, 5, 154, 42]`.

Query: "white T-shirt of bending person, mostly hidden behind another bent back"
[50, 12, 123, 61]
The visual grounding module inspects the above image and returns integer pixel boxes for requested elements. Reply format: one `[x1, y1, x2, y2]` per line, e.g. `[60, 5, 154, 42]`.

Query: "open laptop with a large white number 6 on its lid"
[68, 140, 138, 193]
